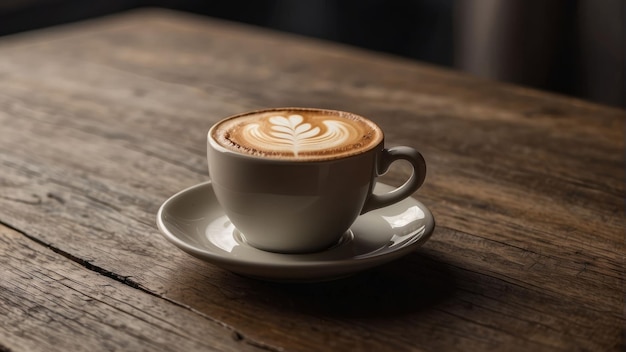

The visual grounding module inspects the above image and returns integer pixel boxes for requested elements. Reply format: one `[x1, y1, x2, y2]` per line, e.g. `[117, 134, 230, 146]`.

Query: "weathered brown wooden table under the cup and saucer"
[0, 10, 626, 352]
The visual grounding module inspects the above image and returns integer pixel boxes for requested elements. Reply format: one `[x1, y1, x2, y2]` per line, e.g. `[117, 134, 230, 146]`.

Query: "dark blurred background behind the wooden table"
[0, 0, 626, 108]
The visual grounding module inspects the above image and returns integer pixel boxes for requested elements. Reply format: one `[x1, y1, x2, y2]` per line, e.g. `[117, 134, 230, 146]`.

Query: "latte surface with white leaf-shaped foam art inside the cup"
[211, 108, 383, 161]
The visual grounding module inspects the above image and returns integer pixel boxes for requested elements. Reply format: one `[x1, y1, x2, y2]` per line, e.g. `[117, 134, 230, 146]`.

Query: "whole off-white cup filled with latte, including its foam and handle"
[207, 108, 426, 253]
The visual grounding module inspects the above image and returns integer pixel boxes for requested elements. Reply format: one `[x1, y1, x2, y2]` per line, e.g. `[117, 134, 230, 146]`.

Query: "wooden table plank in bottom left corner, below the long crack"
[0, 225, 264, 351]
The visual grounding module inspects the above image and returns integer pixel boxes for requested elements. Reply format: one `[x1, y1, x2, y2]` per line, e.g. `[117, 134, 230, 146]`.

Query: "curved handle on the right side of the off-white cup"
[361, 147, 426, 214]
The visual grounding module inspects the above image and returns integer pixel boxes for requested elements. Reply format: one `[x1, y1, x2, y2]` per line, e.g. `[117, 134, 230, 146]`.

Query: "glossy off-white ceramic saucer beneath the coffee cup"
[157, 182, 435, 282]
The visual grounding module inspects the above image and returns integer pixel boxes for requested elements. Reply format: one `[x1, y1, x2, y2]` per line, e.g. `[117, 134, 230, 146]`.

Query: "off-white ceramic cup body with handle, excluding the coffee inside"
[207, 108, 426, 253]
